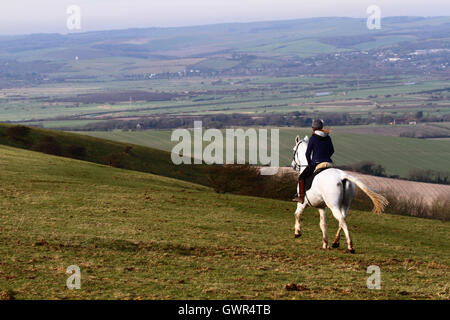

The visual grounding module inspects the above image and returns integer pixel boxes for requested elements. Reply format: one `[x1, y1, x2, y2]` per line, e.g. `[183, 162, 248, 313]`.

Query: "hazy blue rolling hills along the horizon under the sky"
[0, 17, 450, 81]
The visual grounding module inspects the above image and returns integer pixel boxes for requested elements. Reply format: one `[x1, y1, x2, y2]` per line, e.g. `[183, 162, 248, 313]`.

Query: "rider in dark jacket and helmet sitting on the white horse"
[293, 120, 334, 203]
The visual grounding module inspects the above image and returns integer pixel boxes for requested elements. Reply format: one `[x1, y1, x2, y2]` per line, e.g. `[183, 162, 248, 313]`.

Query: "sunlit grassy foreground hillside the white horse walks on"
[0, 146, 450, 299]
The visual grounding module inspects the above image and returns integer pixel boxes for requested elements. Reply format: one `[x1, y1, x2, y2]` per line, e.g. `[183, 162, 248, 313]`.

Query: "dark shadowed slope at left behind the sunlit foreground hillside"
[0, 124, 207, 184]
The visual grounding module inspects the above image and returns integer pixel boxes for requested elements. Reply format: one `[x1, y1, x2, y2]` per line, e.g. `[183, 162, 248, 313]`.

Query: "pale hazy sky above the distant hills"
[0, 0, 450, 35]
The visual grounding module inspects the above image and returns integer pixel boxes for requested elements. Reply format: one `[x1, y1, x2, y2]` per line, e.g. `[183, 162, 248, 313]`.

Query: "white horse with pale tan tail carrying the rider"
[292, 136, 388, 253]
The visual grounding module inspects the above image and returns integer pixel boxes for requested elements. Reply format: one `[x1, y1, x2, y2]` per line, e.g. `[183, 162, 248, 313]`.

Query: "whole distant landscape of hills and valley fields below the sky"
[0, 17, 450, 129]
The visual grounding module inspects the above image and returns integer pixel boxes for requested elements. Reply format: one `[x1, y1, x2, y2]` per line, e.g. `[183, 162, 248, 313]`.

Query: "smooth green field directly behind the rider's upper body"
[82, 128, 450, 177]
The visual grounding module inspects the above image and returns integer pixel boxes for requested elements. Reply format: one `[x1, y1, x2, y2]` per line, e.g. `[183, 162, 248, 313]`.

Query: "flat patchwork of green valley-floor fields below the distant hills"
[4, 76, 450, 124]
